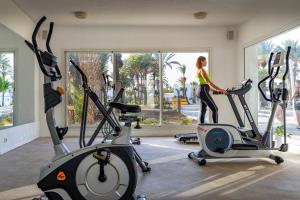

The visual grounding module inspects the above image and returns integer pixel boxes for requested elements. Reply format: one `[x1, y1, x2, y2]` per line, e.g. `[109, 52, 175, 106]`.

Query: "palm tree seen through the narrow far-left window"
[0, 53, 12, 106]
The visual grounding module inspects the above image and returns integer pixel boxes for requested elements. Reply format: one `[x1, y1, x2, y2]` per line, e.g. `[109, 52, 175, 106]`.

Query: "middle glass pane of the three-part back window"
[114, 52, 160, 125]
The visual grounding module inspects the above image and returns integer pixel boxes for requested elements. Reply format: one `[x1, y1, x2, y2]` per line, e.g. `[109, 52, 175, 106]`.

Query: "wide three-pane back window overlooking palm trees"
[66, 52, 209, 126]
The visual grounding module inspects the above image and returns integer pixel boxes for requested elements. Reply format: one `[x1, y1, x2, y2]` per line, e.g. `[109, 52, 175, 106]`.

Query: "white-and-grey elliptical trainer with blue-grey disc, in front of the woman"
[188, 47, 291, 166]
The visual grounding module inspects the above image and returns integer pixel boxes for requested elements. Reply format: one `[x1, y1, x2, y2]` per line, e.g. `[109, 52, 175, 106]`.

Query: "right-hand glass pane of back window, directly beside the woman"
[162, 53, 209, 125]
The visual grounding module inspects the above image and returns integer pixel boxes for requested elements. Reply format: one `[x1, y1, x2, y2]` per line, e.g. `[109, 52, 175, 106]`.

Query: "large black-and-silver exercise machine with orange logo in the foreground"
[25, 17, 146, 200]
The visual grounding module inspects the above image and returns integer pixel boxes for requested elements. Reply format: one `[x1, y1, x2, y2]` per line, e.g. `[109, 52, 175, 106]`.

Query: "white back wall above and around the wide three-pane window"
[40, 23, 236, 136]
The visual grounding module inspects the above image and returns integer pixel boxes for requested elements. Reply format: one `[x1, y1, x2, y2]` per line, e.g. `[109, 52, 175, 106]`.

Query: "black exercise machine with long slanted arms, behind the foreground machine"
[70, 59, 151, 173]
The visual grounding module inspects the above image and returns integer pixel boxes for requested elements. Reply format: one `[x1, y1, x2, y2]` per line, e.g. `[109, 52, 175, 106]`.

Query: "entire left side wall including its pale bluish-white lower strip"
[0, 0, 40, 155]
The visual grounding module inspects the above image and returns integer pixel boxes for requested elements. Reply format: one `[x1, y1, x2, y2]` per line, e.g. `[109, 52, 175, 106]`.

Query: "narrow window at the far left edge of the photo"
[0, 52, 14, 128]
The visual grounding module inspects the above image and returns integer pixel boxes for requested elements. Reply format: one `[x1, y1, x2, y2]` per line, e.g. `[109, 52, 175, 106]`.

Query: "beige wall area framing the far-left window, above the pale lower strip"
[0, 24, 38, 125]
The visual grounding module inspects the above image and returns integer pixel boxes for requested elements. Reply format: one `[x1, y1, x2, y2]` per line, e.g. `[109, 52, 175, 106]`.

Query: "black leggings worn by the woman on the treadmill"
[200, 84, 218, 124]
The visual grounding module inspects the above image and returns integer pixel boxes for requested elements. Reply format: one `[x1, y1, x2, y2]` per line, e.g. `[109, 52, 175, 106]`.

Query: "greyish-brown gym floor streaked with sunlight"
[0, 138, 300, 200]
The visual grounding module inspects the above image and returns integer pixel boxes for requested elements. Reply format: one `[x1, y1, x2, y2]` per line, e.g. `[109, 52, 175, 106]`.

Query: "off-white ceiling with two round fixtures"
[13, 0, 300, 26]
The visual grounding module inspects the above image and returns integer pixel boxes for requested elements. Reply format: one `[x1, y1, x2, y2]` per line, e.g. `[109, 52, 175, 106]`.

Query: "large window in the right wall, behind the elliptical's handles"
[245, 27, 300, 134]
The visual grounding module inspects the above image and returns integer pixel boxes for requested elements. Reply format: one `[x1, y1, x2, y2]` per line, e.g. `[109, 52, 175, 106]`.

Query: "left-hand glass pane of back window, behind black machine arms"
[66, 52, 113, 125]
